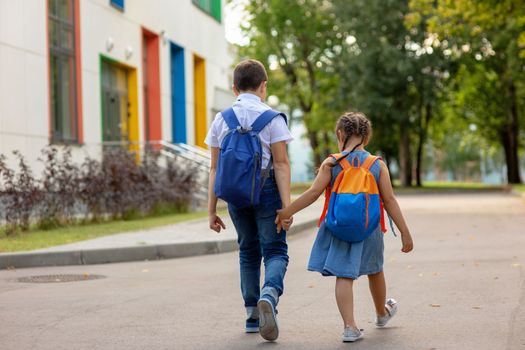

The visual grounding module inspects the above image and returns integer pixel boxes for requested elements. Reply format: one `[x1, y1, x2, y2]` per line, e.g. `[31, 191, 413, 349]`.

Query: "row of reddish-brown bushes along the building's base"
[0, 147, 197, 234]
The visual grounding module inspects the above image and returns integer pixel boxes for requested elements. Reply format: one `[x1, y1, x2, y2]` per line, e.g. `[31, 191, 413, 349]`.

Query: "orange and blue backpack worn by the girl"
[319, 153, 386, 243]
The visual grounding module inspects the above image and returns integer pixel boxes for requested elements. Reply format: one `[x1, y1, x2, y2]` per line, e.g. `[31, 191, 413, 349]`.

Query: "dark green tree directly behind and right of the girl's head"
[334, 0, 446, 186]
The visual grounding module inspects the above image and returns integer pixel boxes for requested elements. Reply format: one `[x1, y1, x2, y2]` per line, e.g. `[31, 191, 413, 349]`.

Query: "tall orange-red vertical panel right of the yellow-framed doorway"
[142, 29, 162, 141]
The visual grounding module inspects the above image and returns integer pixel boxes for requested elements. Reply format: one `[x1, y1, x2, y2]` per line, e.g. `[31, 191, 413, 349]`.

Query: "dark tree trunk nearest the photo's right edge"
[501, 83, 521, 184]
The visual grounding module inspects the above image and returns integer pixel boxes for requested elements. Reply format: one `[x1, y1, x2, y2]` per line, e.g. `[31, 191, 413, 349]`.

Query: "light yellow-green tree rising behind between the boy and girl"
[238, 0, 343, 166]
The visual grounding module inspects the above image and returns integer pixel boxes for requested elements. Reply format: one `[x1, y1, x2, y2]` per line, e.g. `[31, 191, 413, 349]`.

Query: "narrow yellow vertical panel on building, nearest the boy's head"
[193, 56, 208, 148]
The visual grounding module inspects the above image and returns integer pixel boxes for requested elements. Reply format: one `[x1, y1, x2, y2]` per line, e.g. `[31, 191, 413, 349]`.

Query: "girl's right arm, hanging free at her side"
[379, 161, 414, 253]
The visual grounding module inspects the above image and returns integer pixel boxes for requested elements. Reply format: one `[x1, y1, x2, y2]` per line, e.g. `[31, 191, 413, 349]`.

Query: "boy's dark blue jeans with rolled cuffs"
[228, 172, 288, 317]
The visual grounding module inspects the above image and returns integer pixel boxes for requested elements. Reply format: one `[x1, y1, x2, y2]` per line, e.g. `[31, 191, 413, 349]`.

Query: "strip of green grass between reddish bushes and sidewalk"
[0, 211, 223, 253]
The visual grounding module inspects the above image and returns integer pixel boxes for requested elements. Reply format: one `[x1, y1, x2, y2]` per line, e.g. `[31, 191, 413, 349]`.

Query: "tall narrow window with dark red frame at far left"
[48, 0, 79, 143]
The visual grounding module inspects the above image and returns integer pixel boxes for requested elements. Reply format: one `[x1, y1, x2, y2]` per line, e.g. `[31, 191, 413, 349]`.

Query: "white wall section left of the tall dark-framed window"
[0, 0, 49, 170]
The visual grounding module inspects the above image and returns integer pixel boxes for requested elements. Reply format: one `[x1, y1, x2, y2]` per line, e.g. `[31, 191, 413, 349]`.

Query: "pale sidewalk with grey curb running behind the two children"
[0, 198, 323, 269]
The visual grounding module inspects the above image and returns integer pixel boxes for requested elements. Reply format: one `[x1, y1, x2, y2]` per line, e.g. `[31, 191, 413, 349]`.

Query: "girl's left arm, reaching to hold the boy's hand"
[275, 158, 334, 226]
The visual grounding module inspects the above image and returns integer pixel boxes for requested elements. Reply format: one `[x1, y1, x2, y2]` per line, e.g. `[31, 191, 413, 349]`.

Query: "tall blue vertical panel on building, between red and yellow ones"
[171, 43, 186, 143]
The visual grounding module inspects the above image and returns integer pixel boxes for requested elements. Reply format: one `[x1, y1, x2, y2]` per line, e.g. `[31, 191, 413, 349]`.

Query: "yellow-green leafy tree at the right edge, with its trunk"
[411, 0, 525, 183]
